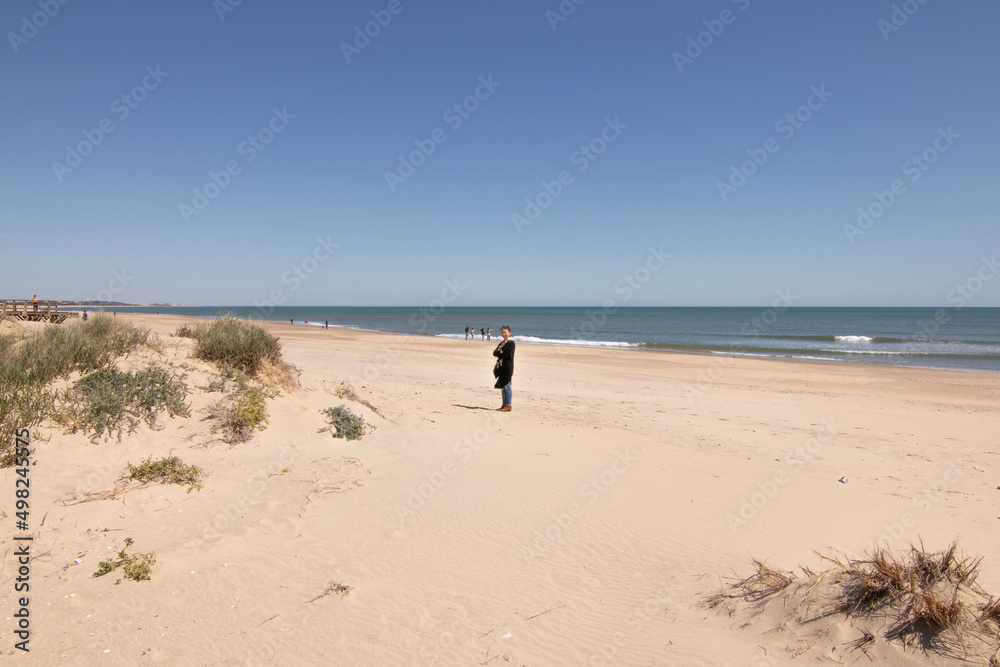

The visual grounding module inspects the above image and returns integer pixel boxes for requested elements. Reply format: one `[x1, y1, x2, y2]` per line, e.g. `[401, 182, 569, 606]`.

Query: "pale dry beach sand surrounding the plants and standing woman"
[0, 314, 1000, 666]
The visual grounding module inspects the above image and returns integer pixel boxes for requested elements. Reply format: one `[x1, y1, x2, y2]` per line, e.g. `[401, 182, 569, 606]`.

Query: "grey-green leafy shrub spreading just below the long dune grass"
[54, 366, 190, 442]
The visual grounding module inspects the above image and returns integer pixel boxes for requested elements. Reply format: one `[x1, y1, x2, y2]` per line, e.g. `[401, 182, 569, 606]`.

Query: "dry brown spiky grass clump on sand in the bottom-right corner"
[706, 543, 1000, 660]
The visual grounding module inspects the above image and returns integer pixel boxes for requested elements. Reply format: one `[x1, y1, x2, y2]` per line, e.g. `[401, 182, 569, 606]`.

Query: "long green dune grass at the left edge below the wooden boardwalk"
[0, 314, 149, 466]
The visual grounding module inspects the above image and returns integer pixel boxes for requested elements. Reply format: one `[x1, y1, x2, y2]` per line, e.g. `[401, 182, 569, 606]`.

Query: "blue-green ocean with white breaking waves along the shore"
[93, 302, 1000, 373]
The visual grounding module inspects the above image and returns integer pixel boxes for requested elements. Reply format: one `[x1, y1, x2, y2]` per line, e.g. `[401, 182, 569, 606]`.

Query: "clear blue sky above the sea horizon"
[0, 0, 1000, 306]
